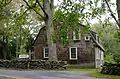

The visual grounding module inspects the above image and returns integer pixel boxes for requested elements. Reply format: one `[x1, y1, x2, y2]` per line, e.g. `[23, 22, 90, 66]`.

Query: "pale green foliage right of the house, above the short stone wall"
[92, 24, 120, 63]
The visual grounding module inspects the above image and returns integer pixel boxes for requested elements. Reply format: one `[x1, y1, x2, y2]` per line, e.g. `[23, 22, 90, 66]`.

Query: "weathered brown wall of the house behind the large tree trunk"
[33, 27, 104, 67]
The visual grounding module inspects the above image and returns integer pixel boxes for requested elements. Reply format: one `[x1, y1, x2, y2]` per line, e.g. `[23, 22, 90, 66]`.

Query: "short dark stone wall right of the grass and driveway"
[101, 62, 120, 76]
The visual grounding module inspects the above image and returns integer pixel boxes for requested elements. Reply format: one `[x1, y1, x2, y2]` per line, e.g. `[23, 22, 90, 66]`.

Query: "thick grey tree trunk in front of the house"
[43, 0, 57, 61]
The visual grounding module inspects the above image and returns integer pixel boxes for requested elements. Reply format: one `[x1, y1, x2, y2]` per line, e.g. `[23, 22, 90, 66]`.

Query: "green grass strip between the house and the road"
[68, 67, 120, 79]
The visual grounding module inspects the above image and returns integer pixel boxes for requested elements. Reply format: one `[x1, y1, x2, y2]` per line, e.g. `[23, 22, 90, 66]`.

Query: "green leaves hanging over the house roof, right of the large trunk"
[54, 0, 105, 45]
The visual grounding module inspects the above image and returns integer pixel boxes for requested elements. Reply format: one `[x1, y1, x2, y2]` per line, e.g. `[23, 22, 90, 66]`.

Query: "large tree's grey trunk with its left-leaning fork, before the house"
[23, 0, 57, 61]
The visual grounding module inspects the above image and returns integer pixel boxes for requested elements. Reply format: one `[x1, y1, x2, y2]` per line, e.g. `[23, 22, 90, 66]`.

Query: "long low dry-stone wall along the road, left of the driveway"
[0, 59, 67, 70]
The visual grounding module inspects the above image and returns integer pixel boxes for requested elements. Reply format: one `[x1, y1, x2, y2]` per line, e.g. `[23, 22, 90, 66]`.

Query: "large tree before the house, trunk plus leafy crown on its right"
[23, 0, 104, 61]
